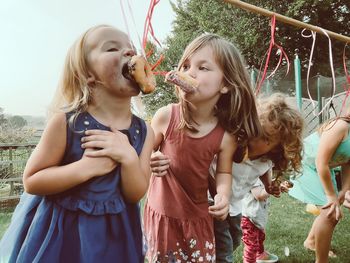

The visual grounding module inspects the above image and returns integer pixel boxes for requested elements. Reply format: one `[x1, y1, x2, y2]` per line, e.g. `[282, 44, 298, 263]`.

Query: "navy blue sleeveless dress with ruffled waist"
[0, 112, 147, 263]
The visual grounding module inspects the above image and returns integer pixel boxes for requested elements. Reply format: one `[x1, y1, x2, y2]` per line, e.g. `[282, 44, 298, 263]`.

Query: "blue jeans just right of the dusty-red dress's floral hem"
[214, 214, 242, 263]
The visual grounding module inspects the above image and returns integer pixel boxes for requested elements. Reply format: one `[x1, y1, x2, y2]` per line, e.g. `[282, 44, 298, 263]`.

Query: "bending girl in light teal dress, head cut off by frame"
[289, 115, 350, 263]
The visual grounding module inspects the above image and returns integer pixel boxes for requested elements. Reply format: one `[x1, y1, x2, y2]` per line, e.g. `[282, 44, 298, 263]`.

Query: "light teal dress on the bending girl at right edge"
[289, 132, 350, 205]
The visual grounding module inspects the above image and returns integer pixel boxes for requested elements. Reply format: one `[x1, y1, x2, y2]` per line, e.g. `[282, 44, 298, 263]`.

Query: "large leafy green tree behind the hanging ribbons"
[145, 0, 350, 114]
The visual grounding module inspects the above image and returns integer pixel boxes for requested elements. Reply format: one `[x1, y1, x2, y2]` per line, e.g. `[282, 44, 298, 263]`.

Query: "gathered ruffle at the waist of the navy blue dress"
[54, 196, 125, 215]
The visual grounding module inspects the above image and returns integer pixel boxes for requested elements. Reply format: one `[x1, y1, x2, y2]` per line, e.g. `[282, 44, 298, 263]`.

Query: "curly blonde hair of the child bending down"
[258, 93, 304, 173]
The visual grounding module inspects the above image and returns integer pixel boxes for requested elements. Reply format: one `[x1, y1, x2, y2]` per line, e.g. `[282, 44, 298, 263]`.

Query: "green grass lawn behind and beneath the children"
[0, 194, 350, 263]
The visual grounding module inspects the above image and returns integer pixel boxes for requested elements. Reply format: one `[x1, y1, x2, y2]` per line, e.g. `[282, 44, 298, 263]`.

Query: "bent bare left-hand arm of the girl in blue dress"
[23, 113, 116, 195]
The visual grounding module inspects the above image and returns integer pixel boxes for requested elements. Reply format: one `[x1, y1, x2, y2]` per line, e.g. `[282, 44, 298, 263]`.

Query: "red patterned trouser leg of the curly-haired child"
[241, 216, 265, 263]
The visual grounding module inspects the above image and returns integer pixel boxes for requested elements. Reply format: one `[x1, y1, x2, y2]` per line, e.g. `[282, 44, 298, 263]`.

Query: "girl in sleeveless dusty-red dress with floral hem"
[144, 34, 261, 262]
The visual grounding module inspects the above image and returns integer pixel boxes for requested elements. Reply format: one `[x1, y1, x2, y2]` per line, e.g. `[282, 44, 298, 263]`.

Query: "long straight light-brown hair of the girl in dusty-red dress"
[177, 34, 262, 161]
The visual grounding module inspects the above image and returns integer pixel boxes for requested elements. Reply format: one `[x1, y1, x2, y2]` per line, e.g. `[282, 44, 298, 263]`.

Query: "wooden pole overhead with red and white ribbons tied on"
[224, 0, 350, 43]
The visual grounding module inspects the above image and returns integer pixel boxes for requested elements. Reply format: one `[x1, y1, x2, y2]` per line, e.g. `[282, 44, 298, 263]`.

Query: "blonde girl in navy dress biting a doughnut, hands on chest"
[0, 25, 154, 263]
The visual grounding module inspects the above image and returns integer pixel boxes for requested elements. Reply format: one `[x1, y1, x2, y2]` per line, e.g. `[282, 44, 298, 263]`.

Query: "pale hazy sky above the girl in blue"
[0, 0, 175, 116]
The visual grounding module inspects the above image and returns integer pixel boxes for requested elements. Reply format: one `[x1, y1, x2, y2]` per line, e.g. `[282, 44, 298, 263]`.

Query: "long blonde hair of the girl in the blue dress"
[49, 25, 111, 119]
